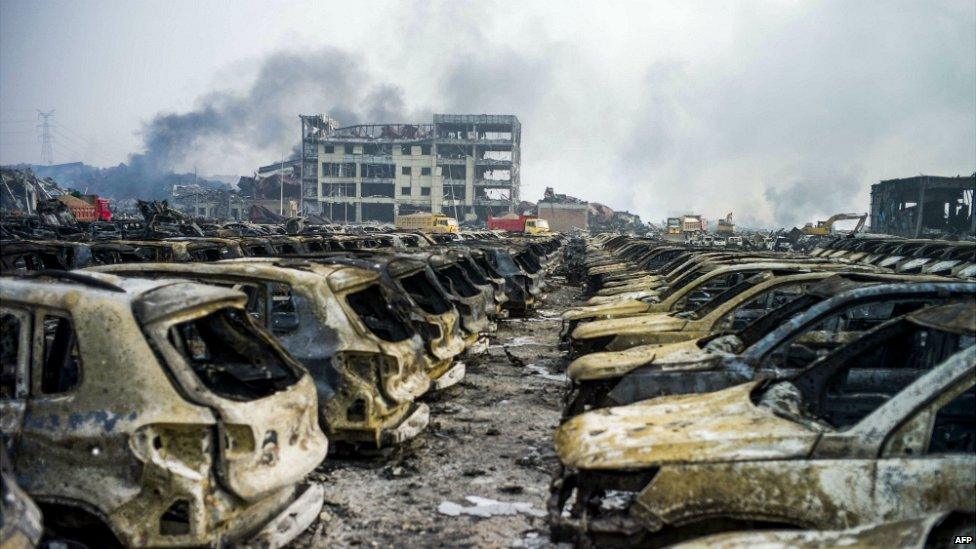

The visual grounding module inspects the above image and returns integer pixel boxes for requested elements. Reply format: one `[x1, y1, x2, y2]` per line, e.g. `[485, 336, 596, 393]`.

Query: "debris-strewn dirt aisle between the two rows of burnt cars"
[295, 277, 580, 547]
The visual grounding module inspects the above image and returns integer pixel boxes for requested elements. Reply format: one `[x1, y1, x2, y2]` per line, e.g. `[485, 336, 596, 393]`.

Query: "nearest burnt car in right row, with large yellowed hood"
[549, 303, 976, 546]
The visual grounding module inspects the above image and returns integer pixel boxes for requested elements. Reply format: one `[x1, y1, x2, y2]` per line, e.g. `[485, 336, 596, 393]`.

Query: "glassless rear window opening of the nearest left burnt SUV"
[169, 309, 299, 400]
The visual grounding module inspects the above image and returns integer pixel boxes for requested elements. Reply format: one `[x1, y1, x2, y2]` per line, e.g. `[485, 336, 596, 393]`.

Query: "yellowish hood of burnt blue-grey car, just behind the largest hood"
[566, 339, 708, 381]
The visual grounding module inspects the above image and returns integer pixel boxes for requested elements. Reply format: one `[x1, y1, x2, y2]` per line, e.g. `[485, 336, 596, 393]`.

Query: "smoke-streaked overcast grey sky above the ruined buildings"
[0, 0, 976, 227]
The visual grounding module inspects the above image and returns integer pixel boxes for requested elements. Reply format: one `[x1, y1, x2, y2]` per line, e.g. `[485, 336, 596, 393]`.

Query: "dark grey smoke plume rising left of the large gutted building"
[129, 47, 416, 177]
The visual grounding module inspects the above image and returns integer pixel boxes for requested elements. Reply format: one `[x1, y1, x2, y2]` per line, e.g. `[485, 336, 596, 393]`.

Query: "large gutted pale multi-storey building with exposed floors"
[300, 114, 522, 222]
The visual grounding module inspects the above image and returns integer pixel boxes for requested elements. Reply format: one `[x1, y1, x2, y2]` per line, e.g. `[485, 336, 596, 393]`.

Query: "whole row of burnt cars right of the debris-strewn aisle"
[549, 235, 976, 547]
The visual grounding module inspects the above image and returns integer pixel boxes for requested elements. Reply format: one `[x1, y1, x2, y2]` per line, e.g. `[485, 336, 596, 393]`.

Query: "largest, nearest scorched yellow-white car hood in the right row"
[556, 382, 820, 469]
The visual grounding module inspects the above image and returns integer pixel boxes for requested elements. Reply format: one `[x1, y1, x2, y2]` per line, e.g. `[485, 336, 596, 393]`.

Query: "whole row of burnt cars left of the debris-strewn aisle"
[0, 226, 561, 547]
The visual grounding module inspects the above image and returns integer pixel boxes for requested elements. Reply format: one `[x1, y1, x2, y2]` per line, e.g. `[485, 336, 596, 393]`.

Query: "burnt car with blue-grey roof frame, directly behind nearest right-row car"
[566, 274, 976, 416]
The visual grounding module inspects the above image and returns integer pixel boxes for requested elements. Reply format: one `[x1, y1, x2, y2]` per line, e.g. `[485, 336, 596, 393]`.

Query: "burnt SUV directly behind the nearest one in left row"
[88, 259, 430, 447]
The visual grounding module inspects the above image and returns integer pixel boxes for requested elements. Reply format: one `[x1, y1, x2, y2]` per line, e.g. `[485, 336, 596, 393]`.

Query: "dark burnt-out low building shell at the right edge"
[871, 174, 976, 238]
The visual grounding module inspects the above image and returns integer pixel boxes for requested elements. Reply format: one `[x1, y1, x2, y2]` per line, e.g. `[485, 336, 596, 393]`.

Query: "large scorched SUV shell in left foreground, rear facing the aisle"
[0, 272, 327, 547]
